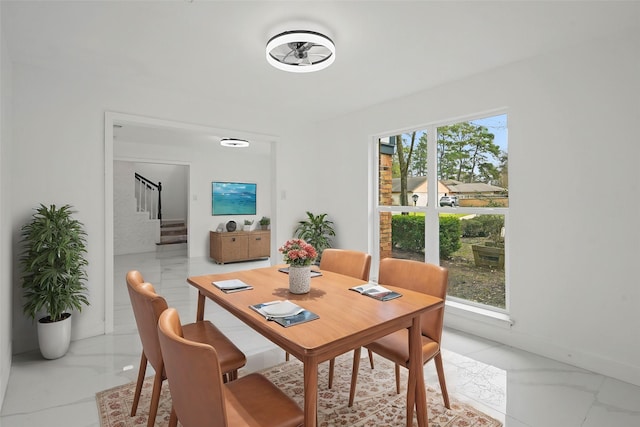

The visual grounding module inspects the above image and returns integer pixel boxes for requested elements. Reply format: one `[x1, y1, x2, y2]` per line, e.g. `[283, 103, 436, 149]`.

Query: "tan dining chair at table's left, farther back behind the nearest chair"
[126, 270, 247, 427]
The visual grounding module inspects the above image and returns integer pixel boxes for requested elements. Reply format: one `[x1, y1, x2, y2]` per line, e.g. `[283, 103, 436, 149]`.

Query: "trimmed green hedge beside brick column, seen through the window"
[391, 215, 460, 259]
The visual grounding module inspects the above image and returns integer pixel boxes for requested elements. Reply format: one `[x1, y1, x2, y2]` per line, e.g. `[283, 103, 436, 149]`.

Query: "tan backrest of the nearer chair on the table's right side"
[378, 258, 449, 343]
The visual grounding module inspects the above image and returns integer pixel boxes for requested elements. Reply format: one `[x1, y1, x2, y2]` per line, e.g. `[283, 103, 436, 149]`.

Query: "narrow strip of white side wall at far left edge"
[0, 8, 14, 407]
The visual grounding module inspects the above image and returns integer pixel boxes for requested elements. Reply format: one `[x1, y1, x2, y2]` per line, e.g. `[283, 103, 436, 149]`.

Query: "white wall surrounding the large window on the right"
[308, 31, 640, 384]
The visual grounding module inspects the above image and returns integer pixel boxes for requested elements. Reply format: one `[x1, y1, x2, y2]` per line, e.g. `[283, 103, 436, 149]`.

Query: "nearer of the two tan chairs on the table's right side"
[349, 258, 450, 419]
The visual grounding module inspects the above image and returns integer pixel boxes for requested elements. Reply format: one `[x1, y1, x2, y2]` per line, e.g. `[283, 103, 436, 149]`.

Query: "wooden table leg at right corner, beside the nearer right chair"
[407, 316, 429, 427]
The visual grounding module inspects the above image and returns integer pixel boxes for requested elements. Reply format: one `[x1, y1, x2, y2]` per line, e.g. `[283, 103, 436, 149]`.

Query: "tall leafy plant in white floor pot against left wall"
[20, 204, 89, 359]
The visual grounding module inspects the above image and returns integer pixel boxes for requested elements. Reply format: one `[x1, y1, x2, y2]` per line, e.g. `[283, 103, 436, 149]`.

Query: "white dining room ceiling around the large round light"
[2, 0, 640, 132]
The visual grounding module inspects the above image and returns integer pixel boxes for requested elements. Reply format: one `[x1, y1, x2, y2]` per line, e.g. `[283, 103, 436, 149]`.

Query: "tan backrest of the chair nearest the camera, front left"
[157, 308, 227, 427]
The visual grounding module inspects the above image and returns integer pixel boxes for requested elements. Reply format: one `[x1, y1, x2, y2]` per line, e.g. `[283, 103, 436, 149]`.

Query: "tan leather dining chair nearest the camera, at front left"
[157, 308, 304, 427]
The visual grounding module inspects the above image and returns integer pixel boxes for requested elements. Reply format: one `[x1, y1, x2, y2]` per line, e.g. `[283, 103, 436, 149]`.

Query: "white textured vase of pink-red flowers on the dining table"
[278, 239, 318, 294]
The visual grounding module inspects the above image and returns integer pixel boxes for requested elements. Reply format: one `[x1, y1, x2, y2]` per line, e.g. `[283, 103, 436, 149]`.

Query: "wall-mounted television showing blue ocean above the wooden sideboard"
[211, 181, 257, 215]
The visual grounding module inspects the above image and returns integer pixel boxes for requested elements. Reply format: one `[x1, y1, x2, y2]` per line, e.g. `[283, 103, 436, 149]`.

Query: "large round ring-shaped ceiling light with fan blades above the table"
[267, 30, 336, 73]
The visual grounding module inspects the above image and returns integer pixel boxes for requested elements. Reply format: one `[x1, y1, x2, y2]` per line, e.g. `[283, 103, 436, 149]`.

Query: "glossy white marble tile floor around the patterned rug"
[0, 251, 640, 427]
